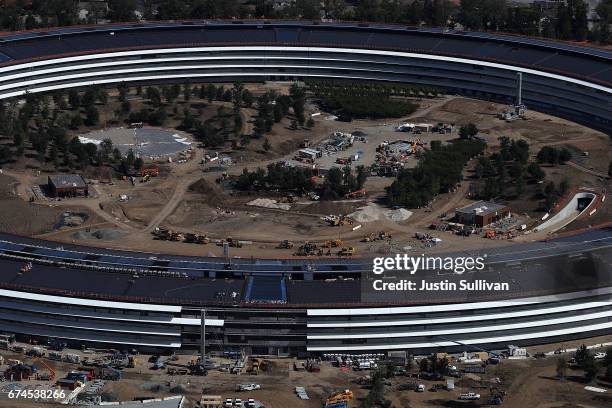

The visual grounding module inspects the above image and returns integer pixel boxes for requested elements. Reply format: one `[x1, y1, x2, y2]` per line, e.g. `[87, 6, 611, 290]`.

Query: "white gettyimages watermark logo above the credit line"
[372, 254, 487, 275]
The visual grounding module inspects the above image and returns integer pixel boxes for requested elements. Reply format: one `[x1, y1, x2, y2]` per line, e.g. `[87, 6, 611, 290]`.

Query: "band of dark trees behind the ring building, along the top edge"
[0, 0, 612, 43]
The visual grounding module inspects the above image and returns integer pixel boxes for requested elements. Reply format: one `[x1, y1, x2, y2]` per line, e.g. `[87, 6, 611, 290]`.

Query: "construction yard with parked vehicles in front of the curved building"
[0, 336, 611, 408]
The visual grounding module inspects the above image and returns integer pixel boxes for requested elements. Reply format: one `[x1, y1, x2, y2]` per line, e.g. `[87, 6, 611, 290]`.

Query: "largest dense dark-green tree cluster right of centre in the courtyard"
[387, 139, 486, 208]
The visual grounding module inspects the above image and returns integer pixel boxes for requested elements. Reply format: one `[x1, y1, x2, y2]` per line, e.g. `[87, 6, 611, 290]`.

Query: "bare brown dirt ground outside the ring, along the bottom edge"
[0, 336, 612, 408]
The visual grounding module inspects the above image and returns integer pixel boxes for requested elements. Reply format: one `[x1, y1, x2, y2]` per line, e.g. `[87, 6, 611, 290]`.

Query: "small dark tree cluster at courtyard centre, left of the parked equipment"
[234, 162, 315, 194]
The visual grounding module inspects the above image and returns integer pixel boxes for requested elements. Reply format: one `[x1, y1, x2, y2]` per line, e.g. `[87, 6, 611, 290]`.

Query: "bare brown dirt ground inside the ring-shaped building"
[0, 94, 612, 256]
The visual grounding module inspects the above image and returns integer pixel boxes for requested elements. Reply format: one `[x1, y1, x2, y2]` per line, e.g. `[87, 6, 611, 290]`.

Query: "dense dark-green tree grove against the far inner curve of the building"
[310, 82, 418, 120]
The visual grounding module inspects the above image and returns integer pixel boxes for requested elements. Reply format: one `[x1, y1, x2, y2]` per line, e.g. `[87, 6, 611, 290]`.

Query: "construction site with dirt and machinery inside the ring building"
[3, 82, 610, 257]
